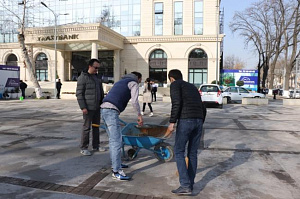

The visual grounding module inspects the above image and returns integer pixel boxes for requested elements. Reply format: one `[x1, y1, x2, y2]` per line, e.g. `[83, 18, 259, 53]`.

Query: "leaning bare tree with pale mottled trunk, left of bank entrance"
[0, 0, 43, 98]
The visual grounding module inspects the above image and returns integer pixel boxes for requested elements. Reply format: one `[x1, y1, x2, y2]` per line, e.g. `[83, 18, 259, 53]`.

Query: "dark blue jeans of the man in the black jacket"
[174, 118, 203, 189]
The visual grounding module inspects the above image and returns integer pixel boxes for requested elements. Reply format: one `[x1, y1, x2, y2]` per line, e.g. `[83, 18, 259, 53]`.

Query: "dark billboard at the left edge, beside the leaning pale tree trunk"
[0, 65, 20, 99]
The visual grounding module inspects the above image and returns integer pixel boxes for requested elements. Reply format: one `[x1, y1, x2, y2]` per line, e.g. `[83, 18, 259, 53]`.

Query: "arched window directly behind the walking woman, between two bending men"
[149, 50, 167, 86]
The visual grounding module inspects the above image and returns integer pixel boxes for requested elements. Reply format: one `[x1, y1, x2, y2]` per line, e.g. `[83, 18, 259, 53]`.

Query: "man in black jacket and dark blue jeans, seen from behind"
[168, 69, 206, 195]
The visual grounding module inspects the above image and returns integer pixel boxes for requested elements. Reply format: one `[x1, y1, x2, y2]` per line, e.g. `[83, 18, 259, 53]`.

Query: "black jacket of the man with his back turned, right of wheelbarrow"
[170, 80, 206, 123]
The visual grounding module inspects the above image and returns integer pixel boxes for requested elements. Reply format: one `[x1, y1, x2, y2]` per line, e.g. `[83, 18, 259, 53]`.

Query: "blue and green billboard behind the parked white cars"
[220, 69, 258, 91]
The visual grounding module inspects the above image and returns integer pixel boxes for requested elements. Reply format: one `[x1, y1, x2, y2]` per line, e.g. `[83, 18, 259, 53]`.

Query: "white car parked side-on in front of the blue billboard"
[223, 86, 265, 102]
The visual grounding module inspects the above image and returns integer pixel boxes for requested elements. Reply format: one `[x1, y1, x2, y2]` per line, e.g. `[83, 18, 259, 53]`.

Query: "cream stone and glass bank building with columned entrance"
[0, 0, 224, 97]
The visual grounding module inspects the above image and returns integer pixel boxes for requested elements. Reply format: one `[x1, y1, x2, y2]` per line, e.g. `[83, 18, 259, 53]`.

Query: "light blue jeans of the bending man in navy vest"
[101, 109, 123, 172]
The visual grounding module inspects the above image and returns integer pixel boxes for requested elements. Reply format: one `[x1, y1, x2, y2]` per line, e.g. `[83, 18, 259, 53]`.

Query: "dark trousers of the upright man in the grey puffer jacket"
[80, 108, 100, 149]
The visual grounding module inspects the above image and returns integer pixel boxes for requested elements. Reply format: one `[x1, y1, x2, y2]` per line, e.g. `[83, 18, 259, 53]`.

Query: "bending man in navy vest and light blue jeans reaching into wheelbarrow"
[101, 72, 143, 180]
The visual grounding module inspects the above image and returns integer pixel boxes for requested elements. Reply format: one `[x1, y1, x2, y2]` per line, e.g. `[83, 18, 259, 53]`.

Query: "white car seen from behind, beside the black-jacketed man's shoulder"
[199, 84, 223, 108]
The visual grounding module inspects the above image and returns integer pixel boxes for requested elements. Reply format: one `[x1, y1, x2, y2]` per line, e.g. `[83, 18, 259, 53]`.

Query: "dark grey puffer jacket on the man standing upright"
[76, 72, 104, 110]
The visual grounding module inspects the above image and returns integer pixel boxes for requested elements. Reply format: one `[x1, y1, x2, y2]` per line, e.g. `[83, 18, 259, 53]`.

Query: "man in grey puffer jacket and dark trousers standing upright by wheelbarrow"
[76, 59, 105, 155]
